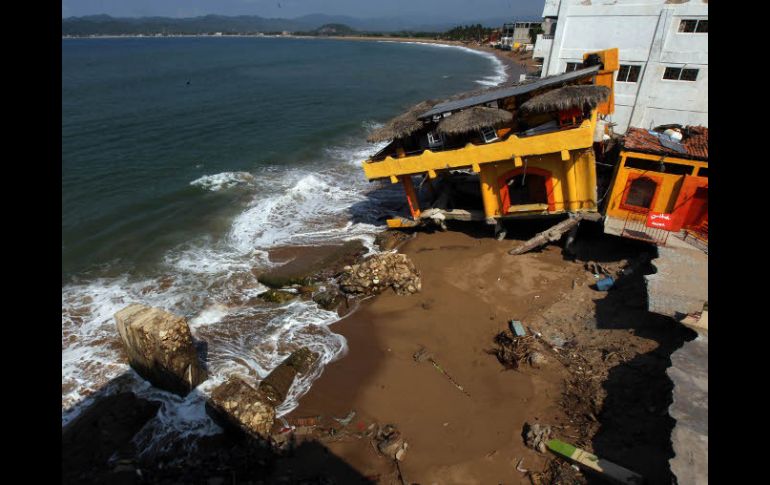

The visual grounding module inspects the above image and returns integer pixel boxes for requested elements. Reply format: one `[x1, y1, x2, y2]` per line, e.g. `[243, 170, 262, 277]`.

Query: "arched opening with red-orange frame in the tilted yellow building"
[498, 167, 556, 214]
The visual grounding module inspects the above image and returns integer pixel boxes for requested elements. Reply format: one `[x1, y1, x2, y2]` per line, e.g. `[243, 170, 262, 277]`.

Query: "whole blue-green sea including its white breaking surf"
[62, 38, 506, 450]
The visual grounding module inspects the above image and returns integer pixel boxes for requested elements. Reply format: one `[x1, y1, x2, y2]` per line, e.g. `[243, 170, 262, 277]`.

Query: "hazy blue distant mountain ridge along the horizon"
[62, 14, 537, 36]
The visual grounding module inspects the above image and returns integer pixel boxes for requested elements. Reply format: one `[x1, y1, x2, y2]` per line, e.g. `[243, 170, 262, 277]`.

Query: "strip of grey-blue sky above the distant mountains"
[62, 0, 544, 21]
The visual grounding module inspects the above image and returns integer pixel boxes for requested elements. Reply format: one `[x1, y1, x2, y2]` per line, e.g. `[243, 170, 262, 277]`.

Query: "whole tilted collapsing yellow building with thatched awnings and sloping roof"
[363, 49, 618, 238]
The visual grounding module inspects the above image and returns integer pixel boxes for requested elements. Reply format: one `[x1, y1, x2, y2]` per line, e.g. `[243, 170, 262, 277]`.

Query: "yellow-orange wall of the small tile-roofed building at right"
[607, 151, 708, 219]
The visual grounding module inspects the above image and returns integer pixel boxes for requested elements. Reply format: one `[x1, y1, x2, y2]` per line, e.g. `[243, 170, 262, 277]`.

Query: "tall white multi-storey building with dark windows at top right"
[533, 0, 708, 133]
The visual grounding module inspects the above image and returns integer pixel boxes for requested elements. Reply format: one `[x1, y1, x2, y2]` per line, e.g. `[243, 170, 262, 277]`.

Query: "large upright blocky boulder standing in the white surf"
[115, 304, 207, 396]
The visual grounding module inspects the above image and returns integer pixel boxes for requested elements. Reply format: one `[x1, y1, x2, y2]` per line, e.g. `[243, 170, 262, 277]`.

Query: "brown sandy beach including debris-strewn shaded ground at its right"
[284, 226, 682, 484]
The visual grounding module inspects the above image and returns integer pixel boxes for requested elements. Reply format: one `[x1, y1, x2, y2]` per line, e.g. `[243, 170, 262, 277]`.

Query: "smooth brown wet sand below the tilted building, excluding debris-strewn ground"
[292, 232, 584, 483]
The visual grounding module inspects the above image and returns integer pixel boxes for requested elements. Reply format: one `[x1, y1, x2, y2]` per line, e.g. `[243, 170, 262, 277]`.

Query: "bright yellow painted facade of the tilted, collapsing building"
[362, 49, 618, 227]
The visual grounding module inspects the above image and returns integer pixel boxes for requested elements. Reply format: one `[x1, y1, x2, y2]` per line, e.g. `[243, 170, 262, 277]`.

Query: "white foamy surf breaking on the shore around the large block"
[62, 133, 392, 453]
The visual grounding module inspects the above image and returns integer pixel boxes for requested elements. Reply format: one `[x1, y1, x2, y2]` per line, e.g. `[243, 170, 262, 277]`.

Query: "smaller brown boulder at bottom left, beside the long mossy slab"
[206, 376, 275, 439]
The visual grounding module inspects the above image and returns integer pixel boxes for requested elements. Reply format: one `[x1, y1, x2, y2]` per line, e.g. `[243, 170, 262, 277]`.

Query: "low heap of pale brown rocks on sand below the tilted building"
[339, 253, 422, 295]
